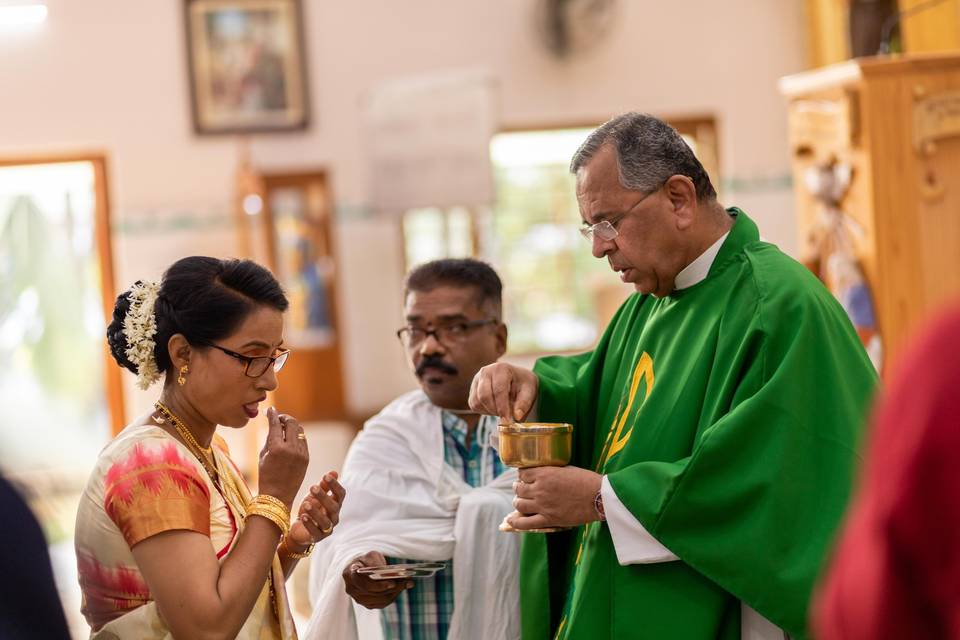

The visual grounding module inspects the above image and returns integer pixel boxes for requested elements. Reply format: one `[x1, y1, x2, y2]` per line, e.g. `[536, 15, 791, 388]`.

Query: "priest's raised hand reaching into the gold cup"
[470, 362, 540, 423]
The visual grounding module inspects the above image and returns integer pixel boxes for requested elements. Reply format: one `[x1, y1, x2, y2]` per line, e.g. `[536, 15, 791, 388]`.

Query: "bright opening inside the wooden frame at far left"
[0, 161, 116, 472]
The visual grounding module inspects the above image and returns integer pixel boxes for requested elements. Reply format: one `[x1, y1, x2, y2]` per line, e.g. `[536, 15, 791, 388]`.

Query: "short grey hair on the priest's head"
[570, 112, 717, 202]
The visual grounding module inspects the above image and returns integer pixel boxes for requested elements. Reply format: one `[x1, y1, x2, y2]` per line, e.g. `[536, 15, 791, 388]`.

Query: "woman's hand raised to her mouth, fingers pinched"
[259, 407, 310, 508]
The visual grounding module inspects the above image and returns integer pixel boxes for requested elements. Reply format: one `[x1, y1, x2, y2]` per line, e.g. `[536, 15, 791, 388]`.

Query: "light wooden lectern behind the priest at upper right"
[780, 54, 960, 371]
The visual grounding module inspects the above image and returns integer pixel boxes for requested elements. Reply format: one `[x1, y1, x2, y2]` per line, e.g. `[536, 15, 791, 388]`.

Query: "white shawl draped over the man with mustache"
[303, 391, 520, 640]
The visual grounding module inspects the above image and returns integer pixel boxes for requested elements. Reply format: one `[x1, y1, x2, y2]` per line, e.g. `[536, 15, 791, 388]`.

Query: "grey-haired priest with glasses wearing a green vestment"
[471, 113, 877, 640]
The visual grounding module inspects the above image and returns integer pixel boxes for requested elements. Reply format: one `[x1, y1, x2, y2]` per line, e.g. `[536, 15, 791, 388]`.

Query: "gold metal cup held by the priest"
[495, 422, 573, 533]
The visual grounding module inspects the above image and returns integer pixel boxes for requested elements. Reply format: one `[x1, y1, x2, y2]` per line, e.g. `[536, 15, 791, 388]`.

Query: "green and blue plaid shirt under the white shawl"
[382, 411, 506, 640]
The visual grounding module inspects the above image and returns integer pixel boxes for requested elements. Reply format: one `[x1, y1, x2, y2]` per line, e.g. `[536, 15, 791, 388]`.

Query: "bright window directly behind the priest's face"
[484, 129, 616, 353]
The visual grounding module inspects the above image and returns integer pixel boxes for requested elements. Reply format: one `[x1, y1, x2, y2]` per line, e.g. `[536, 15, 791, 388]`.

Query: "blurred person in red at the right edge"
[814, 306, 960, 640]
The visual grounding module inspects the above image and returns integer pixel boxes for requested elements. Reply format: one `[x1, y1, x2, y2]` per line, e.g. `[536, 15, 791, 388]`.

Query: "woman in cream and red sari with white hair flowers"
[76, 256, 344, 640]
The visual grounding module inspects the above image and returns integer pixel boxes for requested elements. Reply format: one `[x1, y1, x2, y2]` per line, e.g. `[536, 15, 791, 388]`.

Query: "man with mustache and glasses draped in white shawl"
[304, 259, 519, 640]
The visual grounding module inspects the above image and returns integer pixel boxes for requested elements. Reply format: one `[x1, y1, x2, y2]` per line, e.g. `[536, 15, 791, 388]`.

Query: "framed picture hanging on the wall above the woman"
[184, 0, 309, 134]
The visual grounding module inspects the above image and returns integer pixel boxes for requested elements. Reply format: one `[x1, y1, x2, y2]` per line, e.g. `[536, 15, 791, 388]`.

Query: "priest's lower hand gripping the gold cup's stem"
[507, 467, 603, 531]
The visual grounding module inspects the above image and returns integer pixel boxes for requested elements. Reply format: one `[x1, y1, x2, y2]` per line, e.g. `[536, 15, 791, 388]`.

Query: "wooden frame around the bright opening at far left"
[0, 151, 126, 435]
